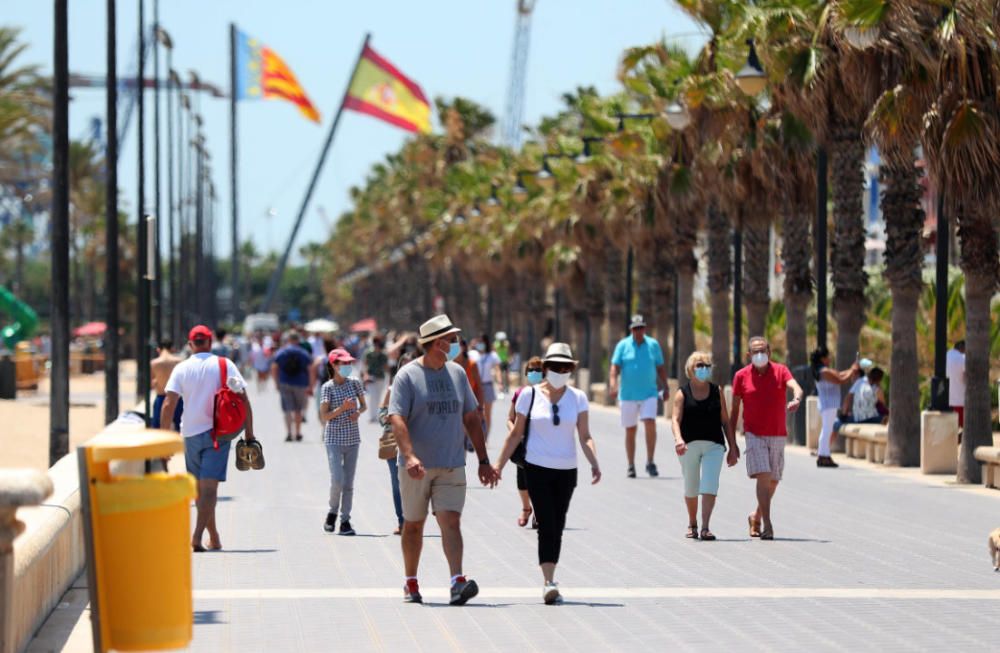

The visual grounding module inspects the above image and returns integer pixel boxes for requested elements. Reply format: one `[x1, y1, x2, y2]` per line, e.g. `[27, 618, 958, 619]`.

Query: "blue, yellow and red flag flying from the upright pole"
[236, 32, 319, 122]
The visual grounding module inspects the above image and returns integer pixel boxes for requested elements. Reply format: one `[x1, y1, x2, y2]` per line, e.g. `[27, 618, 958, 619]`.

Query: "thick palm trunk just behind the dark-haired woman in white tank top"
[820, 125, 868, 384]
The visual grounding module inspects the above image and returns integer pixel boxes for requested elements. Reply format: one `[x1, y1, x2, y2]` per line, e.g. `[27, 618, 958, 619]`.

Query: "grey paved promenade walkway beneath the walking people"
[27, 380, 1000, 653]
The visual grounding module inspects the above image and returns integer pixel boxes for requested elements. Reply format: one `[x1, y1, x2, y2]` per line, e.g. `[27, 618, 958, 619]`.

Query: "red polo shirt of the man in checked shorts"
[733, 362, 792, 437]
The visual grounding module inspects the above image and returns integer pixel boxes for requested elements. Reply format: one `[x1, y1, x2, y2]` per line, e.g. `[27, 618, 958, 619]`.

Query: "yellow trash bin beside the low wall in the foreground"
[79, 425, 196, 651]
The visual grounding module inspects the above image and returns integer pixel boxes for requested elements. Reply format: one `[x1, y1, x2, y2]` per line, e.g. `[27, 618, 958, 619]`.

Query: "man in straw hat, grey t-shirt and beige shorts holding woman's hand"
[389, 315, 497, 605]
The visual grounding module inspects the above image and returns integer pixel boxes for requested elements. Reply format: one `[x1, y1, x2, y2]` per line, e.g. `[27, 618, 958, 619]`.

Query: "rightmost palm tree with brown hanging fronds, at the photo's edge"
[922, 2, 1000, 483]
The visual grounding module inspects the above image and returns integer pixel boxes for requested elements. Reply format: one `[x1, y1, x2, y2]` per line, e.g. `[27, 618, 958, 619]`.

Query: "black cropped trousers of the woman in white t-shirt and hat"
[524, 463, 576, 564]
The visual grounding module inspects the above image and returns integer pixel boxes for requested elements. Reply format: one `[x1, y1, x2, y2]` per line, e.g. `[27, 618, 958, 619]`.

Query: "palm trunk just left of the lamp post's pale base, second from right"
[888, 160, 924, 467]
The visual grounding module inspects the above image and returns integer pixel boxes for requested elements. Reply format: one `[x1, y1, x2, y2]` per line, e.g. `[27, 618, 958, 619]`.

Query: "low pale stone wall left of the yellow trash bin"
[0, 453, 85, 653]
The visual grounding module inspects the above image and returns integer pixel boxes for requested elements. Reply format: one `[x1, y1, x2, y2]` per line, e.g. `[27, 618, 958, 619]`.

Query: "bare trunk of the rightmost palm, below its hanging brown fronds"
[952, 209, 1000, 483]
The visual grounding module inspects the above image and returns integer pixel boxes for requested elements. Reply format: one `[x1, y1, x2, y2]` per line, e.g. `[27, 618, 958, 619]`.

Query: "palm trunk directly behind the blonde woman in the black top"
[708, 202, 733, 385]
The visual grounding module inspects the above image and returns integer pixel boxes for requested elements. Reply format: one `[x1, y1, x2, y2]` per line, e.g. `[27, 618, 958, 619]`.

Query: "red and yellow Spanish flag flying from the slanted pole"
[344, 45, 431, 134]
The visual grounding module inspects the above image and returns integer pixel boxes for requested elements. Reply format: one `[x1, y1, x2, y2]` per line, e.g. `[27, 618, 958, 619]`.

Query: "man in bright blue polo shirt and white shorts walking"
[609, 315, 667, 478]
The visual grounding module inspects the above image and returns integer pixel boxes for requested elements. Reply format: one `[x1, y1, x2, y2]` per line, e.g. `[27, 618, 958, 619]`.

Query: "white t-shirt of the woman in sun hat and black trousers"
[514, 386, 590, 469]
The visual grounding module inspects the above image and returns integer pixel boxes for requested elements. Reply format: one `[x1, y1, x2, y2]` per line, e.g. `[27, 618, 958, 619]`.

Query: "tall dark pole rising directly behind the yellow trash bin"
[104, 0, 121, 424]
